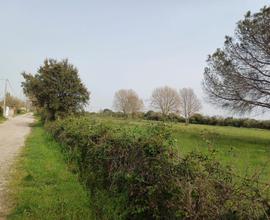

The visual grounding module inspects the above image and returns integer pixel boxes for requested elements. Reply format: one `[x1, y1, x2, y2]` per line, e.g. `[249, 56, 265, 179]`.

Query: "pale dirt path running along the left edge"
[0, 114, 34, 220]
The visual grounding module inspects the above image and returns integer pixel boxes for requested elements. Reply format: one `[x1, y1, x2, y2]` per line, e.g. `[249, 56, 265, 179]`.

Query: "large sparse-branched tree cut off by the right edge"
[203, 7, 270, 113]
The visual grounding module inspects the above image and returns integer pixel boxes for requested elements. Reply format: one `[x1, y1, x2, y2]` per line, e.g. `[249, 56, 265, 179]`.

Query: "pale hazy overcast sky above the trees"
[0, 0, 269, 117]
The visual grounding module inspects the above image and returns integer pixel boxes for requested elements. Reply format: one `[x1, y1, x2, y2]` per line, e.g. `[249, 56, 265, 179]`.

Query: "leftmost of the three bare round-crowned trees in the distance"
[113, 89, 144, 115]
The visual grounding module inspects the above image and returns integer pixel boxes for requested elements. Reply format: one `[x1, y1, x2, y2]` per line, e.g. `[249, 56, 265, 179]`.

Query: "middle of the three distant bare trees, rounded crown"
[150, 86, 180, 115]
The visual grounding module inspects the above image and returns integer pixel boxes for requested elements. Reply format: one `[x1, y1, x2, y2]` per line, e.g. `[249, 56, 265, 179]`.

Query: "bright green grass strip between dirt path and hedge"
[8, 122, 92, 219]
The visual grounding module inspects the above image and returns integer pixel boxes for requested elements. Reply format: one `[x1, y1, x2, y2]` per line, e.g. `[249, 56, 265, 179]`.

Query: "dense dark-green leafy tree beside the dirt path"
[22, 59, 90, 120]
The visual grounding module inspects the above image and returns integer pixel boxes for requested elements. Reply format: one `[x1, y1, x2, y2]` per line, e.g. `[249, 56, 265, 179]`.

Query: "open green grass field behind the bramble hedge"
[94, 117, 270, 181]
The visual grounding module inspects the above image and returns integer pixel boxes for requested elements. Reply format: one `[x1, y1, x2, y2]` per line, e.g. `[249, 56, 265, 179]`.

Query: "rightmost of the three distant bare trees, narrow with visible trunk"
[179, 88, 202, 124]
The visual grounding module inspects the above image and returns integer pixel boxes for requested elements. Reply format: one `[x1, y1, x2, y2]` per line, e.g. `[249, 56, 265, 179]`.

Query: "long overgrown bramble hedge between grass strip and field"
[46, 117, 270, 219]
